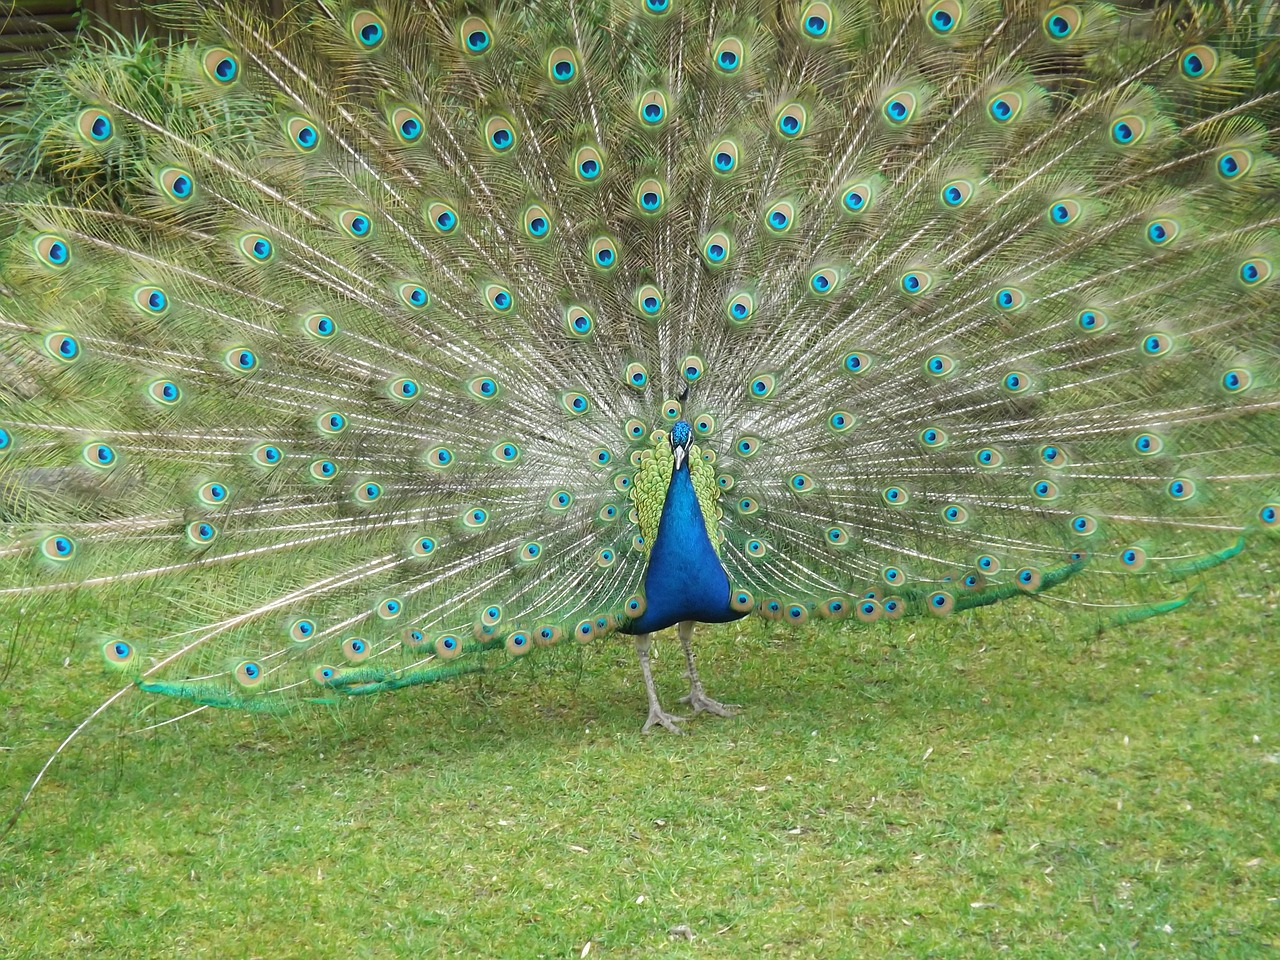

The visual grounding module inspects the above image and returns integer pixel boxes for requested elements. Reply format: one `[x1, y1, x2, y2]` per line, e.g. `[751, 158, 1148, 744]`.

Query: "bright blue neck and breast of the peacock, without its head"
[625, 463, 745, 634]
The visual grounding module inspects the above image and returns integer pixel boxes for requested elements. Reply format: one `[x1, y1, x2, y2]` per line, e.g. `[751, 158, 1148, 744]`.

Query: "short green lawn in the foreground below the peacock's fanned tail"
[0, 564, 1280, 960]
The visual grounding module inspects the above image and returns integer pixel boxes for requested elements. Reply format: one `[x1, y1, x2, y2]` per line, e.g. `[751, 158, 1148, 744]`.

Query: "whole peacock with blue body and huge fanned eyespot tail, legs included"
[0, 0, 1280, 798]
